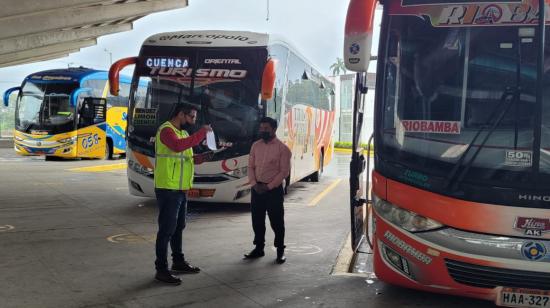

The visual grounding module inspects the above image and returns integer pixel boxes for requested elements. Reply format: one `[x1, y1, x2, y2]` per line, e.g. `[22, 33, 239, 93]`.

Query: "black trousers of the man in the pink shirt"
[251, 185, 285, 248]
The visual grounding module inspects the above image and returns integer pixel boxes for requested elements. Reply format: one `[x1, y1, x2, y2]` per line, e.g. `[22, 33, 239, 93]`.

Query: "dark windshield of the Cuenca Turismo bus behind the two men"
[128, 49, 266, 160]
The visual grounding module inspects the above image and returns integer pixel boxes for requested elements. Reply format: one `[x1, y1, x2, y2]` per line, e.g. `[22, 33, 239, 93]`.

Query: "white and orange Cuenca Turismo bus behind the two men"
[110, 31, 334, 203]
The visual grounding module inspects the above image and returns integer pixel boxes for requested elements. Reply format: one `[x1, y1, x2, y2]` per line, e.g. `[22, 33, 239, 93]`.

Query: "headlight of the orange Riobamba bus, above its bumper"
[373, 195, 444, 232]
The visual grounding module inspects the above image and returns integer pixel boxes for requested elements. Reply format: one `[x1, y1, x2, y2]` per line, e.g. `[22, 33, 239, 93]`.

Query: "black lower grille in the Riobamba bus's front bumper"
[445, 259, 550, 290]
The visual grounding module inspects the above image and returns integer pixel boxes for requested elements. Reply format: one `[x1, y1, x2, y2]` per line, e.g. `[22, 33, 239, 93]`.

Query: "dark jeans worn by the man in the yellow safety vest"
[155, 189, 187, 271]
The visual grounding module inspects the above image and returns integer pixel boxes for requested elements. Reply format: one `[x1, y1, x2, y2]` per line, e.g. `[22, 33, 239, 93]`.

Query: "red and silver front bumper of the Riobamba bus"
[373, 211, 550, 306]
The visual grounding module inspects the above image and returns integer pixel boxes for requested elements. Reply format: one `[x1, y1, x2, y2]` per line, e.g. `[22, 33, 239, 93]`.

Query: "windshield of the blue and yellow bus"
[15, 81, 78, 134]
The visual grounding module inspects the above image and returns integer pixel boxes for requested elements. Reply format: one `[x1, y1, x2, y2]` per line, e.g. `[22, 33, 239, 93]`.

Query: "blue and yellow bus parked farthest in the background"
[4, 67, 131, 159]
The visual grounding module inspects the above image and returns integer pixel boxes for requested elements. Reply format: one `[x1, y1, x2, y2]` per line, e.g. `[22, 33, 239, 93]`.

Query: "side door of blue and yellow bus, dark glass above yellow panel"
[77, 97, 108, 158]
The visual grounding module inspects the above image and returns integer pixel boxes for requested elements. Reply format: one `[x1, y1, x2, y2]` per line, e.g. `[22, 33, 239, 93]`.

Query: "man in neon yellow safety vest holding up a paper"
[155, 105, 212, 285]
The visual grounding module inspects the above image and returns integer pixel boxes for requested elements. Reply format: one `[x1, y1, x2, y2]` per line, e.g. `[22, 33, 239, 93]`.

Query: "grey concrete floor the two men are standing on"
[0, 149, 492, 308]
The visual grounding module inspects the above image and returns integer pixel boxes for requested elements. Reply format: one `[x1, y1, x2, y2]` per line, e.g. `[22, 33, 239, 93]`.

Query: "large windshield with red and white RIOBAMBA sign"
[377, 16, 550, 205]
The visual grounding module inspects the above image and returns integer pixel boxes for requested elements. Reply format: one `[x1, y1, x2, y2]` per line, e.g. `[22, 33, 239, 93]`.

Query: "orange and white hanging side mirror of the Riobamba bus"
[344, 0, 378, 72]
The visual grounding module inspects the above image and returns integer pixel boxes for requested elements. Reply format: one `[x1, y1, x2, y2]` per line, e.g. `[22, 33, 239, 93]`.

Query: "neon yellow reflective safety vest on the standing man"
[155, 121, 194, 190]
